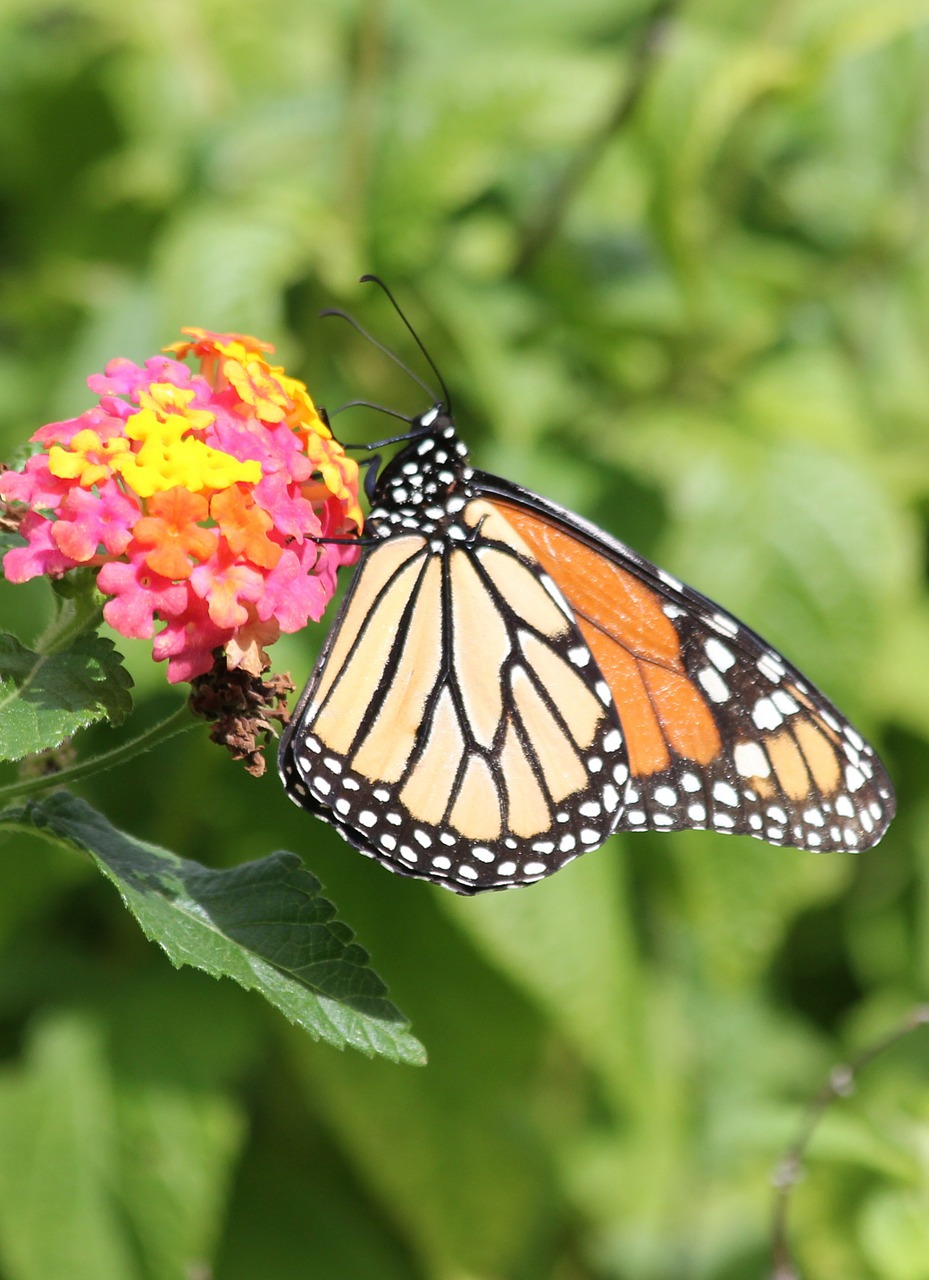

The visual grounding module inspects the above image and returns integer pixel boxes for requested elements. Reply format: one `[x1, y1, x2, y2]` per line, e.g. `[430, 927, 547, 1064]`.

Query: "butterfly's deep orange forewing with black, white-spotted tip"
[473, 474, 894, 851]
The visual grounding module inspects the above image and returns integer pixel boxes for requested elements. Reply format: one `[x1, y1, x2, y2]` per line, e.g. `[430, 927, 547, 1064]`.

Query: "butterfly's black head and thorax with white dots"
[366, 406, 473, 538]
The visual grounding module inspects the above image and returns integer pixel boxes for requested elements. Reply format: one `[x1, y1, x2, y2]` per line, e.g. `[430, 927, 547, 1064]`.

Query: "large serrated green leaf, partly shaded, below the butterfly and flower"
[0, 791, 425, 1065]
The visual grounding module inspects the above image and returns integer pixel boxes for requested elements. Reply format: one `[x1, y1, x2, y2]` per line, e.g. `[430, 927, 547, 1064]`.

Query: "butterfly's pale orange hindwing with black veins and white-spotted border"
[279, 517, 628, 893]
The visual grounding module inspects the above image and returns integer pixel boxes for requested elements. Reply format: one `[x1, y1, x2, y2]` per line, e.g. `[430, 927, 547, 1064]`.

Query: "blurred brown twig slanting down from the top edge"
[511, 0, 681, 276]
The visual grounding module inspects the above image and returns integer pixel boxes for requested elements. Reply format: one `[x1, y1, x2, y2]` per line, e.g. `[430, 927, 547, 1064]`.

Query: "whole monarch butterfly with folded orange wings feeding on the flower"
[279, 293, 894, 893]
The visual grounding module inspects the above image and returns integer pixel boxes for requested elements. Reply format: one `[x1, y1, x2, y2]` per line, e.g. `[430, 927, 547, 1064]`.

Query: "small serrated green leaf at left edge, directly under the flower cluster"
[0, 632, 132, 760]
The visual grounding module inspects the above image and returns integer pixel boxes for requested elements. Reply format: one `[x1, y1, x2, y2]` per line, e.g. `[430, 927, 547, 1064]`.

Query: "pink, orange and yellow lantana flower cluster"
[0, 329, 362, 682]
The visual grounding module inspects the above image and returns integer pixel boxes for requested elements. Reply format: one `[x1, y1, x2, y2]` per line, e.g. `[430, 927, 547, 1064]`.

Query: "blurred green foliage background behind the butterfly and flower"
[0, 0, 929, 1280]
